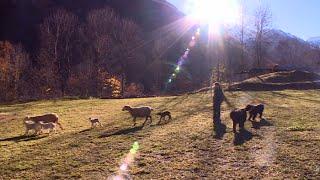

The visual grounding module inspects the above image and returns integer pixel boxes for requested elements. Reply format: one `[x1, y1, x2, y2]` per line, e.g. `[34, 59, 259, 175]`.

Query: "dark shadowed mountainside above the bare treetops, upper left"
[0, 0, 183, 49]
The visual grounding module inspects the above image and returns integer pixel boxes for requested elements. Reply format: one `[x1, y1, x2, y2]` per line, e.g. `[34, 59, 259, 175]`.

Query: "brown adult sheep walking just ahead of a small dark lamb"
[122, 105, 153, 126]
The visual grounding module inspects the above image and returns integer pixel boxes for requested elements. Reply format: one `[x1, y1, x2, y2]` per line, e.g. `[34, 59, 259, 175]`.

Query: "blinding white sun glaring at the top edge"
[186, 0, 240, 26]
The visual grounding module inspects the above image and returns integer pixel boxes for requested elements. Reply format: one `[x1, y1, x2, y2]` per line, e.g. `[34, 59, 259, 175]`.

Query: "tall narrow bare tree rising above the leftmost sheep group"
[38, 9, 78, 94]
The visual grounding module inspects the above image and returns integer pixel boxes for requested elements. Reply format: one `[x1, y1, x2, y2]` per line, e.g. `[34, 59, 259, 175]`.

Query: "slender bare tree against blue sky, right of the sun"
[254, 6, 272, 67]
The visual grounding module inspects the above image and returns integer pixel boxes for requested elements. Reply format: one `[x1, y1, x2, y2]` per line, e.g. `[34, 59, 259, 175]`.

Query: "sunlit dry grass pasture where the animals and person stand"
[0, 90, 320, 179]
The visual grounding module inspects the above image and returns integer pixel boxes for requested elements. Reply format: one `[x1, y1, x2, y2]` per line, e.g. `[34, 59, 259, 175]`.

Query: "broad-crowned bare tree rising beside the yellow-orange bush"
[86, 8, 144, 94]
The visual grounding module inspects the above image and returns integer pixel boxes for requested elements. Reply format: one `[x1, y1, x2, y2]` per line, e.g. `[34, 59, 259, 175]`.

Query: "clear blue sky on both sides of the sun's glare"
[168, 0, 320, 40]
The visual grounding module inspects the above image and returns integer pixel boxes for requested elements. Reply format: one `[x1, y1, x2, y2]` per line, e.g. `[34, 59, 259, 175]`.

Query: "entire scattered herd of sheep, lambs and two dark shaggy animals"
[23, 104, 264, 135]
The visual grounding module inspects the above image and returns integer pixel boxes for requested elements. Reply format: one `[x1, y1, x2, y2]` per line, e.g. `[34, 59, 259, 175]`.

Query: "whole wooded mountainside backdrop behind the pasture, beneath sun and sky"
[0, 0, 320, 102]
